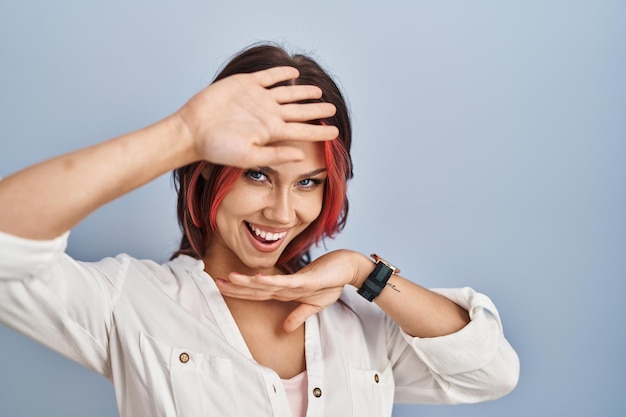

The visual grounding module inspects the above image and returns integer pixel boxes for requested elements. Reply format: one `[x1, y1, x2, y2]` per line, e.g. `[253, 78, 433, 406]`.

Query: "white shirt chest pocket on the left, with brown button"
[140, 333, 243, 417]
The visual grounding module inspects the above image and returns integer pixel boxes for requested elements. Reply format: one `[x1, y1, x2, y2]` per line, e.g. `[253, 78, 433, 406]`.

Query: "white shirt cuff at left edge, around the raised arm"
[0, 231, 70, 280]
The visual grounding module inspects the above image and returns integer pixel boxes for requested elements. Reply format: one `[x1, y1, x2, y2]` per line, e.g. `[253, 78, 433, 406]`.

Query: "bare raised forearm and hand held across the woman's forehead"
[0, 67, 338, 239]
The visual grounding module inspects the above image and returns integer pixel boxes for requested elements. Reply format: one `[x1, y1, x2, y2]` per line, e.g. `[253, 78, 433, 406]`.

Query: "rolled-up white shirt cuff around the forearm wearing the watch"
[402, 288, 503, 375]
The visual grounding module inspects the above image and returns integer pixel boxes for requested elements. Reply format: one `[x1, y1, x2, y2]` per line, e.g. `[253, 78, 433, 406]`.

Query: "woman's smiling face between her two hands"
[210, 142, 326, 273]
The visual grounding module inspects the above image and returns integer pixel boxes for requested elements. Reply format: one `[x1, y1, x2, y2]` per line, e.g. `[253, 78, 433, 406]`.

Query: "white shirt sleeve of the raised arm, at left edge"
[0, 232, 129, 378]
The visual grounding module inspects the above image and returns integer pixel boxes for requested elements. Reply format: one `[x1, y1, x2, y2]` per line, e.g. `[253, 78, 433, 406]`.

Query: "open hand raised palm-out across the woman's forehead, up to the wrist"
[177, 67, 338, 168]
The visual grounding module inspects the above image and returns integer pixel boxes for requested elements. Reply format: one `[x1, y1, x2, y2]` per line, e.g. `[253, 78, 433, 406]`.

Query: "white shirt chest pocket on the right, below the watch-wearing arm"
[349, 365, 395, 417]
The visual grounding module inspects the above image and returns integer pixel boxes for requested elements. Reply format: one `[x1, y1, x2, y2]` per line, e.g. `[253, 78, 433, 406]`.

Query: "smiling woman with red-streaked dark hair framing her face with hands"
[0, 45, 519, 417]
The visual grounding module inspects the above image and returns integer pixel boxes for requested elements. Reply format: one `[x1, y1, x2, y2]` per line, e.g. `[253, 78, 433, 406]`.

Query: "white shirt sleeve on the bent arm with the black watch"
[387, 288, 519, 404]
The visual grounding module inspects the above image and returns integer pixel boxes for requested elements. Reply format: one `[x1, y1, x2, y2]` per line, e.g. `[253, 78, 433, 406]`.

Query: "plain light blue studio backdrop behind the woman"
[0, 0, 626, 417]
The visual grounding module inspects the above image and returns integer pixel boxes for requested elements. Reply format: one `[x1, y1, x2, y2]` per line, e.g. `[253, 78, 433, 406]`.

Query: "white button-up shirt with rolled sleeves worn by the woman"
[0, 232, 519, 417]
